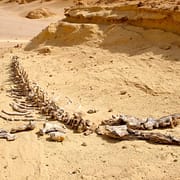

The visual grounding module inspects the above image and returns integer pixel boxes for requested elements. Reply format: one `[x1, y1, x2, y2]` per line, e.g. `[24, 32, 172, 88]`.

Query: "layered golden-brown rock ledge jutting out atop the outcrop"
[65, 3, 180, 34]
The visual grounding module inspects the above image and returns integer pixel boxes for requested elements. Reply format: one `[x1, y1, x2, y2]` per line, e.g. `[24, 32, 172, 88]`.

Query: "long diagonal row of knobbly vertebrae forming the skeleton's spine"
[11, 56, 94, 135]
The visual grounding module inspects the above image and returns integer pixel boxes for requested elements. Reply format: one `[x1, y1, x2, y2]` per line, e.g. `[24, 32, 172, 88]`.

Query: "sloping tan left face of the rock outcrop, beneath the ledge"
[25, 22, 102, 50]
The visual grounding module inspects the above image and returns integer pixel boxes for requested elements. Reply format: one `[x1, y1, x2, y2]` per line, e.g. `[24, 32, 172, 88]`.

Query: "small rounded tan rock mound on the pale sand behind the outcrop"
[26, 8, 55, 19]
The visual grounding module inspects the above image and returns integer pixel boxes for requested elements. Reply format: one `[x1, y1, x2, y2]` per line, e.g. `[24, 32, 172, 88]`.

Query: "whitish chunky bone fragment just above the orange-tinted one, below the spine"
[39, 123, 66, 135]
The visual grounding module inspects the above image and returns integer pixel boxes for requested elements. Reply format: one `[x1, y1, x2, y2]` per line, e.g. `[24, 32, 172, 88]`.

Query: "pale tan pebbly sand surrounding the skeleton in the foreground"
[0, 0, 180, 180]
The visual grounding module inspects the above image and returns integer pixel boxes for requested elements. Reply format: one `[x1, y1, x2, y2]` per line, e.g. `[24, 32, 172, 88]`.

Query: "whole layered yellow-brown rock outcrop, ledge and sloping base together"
[25, 0, 180, 50]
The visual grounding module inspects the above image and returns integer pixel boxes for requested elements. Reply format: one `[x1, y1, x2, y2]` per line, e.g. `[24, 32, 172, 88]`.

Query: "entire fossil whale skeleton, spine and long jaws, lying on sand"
[1, 56, 180, 145]
